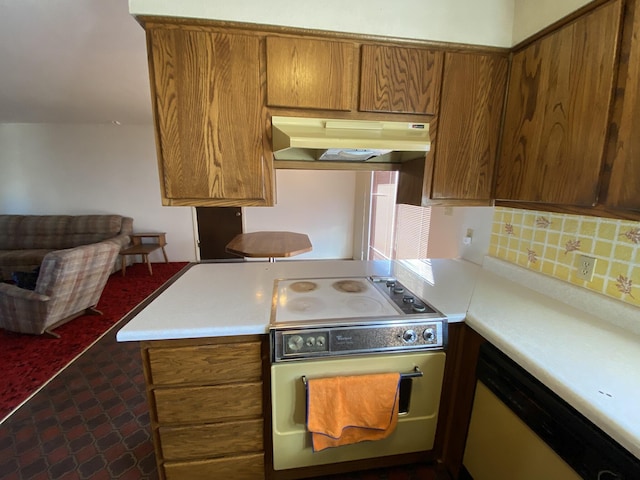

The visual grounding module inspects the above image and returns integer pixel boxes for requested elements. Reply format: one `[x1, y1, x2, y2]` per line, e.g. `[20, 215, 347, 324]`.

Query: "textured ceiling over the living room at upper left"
[0, 0, 151, 124]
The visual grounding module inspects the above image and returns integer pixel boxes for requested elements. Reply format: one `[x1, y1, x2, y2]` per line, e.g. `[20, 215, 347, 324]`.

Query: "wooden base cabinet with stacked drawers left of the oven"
[141, 335, 268, 480]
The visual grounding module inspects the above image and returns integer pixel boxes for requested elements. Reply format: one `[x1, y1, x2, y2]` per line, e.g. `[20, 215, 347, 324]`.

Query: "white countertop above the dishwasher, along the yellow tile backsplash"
[466, 259, 640, 458]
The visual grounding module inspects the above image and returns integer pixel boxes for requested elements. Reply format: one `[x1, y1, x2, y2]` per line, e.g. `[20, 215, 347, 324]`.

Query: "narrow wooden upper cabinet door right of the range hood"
[430, 53, 508, 203]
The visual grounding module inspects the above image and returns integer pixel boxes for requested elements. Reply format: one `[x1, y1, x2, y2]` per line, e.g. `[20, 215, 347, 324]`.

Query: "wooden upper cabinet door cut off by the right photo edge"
[604, 2, 640, 210]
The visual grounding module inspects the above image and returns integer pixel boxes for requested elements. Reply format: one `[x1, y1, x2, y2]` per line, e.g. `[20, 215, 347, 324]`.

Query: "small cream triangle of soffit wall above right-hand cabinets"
[513, 0, 591, 45]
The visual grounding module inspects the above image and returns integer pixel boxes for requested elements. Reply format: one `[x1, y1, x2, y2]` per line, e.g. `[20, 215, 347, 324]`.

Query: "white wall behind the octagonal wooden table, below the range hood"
[243, 170, 356, 260]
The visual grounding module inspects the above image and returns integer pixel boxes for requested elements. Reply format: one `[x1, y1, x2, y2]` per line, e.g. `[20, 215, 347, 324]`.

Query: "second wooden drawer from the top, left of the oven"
[153, 383, 262, 424]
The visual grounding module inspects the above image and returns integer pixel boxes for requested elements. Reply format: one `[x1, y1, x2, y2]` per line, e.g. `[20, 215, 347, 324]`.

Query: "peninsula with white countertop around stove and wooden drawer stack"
[117, 260, 479, 480]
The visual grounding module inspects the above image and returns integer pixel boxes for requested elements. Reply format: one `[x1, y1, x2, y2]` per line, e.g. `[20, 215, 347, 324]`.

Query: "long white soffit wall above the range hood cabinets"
[129, 0, 516, 47]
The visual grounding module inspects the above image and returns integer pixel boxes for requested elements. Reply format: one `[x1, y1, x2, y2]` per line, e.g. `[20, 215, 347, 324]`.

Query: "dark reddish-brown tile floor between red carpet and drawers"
[0, 326, 439, 480]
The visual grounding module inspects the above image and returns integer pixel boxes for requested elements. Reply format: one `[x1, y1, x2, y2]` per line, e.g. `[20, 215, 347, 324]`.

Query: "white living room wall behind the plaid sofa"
[0, 124, 195, 262]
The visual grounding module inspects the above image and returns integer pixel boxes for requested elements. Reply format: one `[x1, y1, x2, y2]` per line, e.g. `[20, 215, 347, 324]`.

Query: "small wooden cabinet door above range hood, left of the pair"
[266, 37, 357, 111]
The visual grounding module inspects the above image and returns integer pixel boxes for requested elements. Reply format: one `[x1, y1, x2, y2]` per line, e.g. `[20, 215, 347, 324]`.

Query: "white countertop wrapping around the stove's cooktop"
[117, 259, 480, 341]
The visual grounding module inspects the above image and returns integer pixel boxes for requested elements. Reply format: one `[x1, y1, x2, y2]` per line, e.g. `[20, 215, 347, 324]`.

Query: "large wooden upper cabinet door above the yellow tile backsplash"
[496, 0, 621, 206]
